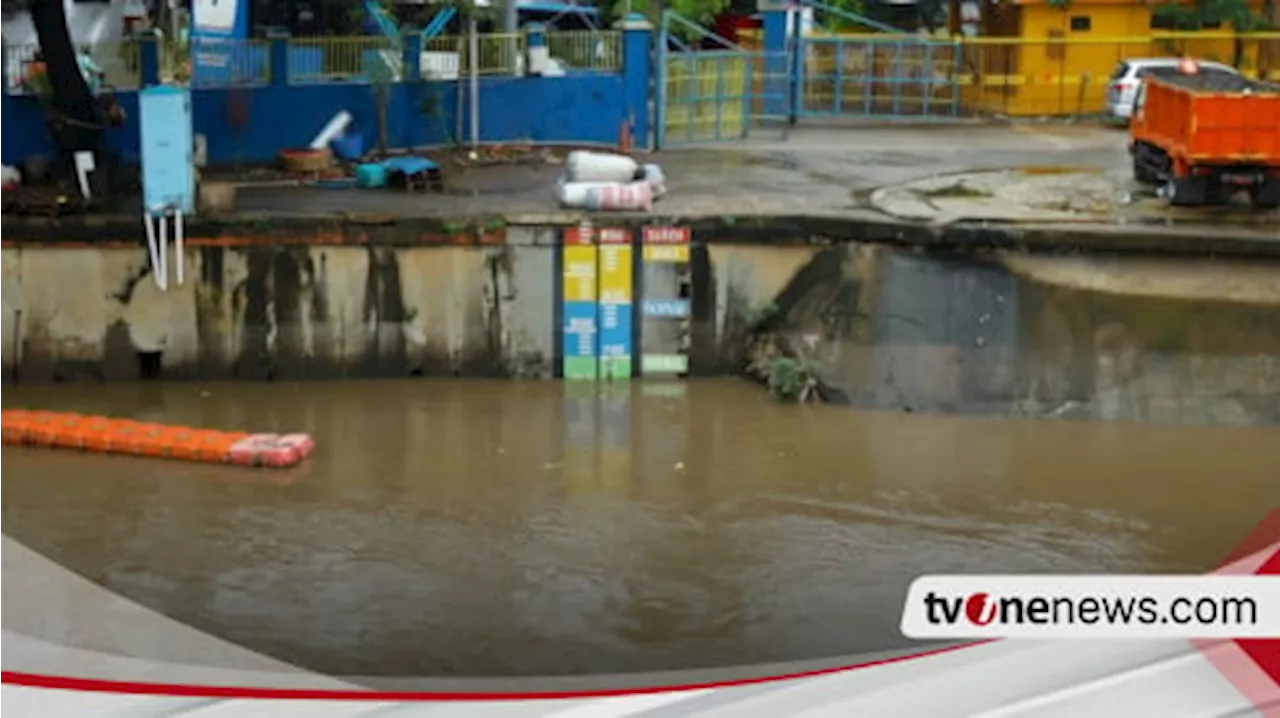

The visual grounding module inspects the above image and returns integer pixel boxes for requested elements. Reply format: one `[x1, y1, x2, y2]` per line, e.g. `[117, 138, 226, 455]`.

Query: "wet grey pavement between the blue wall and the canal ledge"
[194, 123, 1280, 241]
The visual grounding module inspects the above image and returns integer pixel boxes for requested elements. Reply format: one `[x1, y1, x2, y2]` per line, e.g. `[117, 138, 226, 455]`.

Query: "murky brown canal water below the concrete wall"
[0, 379, 1280, 676]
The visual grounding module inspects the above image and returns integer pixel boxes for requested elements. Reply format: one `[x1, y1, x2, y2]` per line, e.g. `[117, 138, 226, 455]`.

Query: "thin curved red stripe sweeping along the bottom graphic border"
[0, 641, 991, 703]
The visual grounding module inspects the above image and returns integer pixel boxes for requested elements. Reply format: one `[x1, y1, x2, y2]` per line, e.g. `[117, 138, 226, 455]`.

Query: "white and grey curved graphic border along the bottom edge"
[0, 538, 1280, 718]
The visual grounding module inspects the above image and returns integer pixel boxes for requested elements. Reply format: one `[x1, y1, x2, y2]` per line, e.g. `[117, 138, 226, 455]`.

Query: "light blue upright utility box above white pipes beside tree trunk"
[138, 86, 196, 215]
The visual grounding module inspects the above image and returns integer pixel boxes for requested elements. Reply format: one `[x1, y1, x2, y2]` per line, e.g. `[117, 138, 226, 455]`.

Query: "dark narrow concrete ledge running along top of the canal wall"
[0, 212, 1280, 259]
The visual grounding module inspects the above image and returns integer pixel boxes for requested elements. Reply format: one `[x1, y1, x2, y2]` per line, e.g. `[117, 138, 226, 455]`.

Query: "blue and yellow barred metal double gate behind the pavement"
[657, 0, 961, 147]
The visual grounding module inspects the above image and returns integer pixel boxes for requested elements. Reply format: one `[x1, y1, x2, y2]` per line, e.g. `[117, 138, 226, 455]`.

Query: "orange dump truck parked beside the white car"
[1129, 73, 1280, 210]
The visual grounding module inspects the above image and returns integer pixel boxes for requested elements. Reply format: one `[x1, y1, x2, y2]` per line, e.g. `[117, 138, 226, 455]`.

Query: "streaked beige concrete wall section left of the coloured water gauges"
[0, 229, 556, 381]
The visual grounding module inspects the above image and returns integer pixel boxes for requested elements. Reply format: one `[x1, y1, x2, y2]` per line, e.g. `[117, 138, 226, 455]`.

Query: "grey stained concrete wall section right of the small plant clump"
[737, 244, 1280, 425]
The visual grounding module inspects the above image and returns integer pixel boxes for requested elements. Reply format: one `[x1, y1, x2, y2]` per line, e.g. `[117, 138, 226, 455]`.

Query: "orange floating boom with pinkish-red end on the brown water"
[0, 410, 315, 468]
